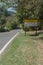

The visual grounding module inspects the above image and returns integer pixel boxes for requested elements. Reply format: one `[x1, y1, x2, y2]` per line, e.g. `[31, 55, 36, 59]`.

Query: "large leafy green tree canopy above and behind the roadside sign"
[17, 0, 43, 30]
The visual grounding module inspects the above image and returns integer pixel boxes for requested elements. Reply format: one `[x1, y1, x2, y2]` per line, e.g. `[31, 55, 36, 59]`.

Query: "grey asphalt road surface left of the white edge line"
[0, 30, 20, 50]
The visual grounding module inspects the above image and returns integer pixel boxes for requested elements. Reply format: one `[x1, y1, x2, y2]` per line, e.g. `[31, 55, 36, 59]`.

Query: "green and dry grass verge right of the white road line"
[0, 33, 43, 65]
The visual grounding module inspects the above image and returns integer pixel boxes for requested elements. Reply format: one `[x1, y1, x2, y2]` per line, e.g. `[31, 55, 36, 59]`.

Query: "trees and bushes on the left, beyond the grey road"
[0, 1, 19, 32]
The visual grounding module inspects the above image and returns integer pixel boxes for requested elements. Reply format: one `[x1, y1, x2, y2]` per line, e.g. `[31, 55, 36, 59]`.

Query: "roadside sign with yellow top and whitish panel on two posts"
[24, 20, 38, 36]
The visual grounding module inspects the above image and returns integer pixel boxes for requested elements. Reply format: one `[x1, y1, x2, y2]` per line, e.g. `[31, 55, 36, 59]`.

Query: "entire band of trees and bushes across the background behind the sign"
[0, 0, 43, 31]
